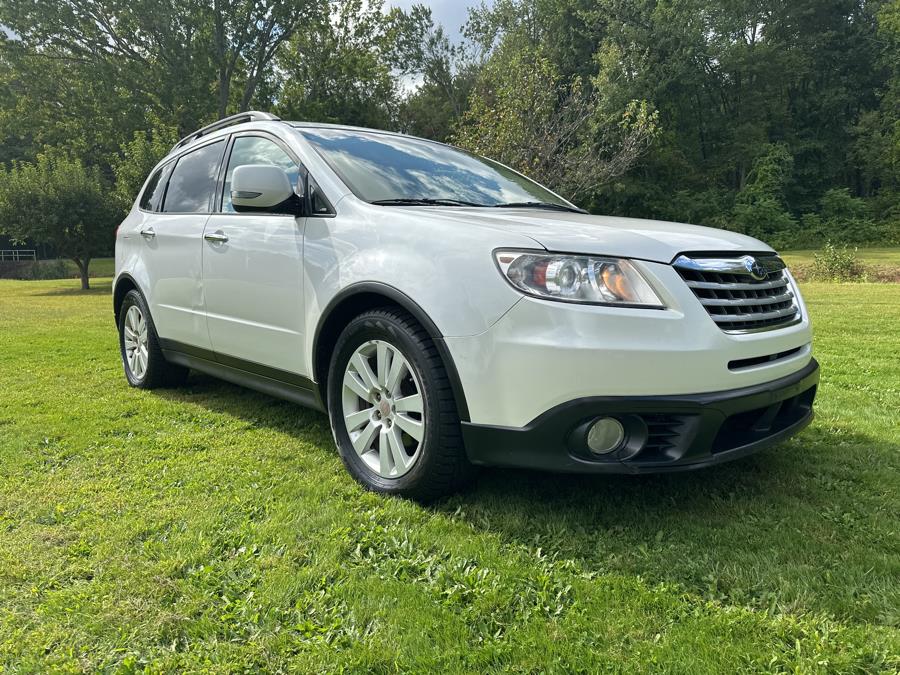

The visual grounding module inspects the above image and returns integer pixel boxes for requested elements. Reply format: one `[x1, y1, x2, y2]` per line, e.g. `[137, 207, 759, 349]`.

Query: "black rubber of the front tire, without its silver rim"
[328, 312, 444, 494]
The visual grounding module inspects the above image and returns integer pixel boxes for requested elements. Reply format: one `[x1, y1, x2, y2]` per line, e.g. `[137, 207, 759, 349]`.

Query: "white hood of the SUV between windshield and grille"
[415, 207, 772, 263]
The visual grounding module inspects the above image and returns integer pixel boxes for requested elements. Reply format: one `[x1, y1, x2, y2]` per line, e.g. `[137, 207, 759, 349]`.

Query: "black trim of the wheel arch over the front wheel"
[312, 282, 469, 422]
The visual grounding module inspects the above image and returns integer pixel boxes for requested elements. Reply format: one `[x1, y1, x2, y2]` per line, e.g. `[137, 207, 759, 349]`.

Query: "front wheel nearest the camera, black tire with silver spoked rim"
[328, 308, 474, 501]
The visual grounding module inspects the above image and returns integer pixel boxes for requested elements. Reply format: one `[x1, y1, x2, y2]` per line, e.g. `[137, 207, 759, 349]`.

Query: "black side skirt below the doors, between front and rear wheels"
[159, 338, 326, 412]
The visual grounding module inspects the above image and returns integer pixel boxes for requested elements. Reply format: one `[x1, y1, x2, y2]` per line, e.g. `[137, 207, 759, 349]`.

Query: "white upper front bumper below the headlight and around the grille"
[443, 260, 812, 427]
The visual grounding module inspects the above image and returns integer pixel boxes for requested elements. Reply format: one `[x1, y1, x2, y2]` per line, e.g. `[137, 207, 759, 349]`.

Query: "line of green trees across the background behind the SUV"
[0, 0, 900, 283]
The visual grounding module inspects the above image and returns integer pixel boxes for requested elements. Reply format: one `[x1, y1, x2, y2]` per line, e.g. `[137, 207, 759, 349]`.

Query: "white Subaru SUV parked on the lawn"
[113, 112, 819, 499]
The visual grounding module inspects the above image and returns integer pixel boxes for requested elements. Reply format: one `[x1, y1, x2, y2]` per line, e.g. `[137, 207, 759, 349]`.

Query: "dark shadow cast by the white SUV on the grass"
[158, 374, 900, 625]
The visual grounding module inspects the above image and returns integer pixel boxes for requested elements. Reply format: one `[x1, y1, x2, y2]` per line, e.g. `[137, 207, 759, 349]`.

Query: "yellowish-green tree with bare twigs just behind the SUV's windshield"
[455, 11, 658, 200]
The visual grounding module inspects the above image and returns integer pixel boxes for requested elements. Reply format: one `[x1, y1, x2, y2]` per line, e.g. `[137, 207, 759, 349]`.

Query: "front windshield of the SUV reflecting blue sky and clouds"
[301, 128, 571, 208]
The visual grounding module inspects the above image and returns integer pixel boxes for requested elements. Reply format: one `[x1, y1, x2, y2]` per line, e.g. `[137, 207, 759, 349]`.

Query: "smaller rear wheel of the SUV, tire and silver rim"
[119, 290, 188, 389]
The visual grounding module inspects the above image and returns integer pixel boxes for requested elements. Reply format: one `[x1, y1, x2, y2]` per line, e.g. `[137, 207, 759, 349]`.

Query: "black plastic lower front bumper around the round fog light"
[463, 359, 819, 473]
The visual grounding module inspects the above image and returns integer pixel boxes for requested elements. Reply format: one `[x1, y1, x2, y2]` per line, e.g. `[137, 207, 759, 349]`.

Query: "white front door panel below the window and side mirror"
[203, 214, 309, 376]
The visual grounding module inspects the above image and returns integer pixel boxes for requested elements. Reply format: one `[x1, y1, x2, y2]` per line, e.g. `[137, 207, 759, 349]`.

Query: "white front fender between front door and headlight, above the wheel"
[304, 210, 534, 348]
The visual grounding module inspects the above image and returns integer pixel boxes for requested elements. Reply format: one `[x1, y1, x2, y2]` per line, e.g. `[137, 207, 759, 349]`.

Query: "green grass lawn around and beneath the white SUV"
[0, 281, 900, 673]
